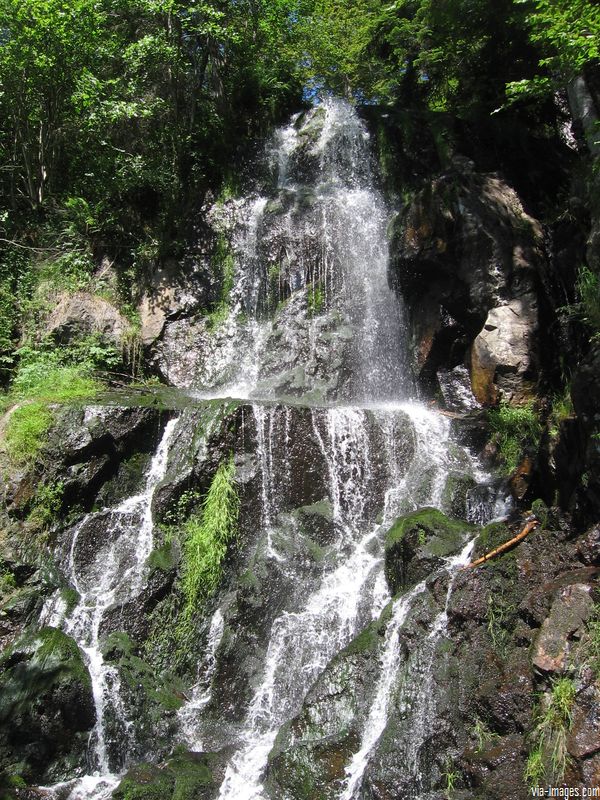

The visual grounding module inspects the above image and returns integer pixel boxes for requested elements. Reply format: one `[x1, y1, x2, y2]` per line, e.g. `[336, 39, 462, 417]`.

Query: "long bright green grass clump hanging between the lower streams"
[182, 457, 239, 623]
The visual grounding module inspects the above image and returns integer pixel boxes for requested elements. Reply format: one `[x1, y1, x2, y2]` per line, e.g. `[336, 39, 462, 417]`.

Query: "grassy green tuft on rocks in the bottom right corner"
[524, 677, 577, 785]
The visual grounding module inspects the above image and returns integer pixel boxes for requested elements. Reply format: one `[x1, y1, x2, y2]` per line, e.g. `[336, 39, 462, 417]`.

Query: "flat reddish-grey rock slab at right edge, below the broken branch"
[532, 584, 594, 672]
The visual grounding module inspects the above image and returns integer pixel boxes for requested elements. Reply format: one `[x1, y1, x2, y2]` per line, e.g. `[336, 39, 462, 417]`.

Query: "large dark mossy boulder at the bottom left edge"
[0, 628, 95, 782]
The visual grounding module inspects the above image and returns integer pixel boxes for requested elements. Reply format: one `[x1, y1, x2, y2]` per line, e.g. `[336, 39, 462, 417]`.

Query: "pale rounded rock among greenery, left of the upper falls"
[46, 292, 130, 347]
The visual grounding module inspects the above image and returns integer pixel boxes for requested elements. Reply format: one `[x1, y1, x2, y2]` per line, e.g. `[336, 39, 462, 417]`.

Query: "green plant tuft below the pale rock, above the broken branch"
[489, 402, 542, 474]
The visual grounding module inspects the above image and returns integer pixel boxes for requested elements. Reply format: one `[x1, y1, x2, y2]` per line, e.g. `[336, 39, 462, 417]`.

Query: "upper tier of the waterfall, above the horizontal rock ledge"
[192, 100, 412, 403]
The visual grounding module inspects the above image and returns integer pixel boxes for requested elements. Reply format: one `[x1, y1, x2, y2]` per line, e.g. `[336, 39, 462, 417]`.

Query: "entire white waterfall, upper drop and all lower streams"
[38, 100, 506, 800]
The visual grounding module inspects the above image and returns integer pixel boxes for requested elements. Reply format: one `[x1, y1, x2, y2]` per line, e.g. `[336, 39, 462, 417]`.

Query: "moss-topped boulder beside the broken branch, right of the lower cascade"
[385, 508, 475, 595]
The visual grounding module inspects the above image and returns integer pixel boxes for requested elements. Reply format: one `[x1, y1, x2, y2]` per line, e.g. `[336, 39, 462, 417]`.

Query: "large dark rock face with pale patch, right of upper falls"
[392, 169, 543, 405]
